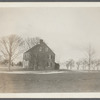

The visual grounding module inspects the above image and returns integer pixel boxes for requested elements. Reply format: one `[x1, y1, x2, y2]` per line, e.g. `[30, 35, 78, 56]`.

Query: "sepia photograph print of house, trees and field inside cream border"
[0, 2, 100, 96]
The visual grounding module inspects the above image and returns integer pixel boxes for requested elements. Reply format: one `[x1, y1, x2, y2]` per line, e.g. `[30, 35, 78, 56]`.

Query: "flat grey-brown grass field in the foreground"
[0, 72, 100, 93]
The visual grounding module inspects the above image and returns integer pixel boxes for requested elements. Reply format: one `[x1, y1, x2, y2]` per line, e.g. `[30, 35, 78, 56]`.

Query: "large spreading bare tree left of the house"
[0, 34, 23, 70]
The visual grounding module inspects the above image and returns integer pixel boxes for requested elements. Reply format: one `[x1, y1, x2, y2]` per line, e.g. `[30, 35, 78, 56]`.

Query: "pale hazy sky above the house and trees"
[0, 7, 100, 61]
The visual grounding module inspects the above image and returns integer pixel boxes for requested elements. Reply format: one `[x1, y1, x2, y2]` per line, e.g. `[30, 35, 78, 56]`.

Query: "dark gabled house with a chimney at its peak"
[23, 40, 55, 70]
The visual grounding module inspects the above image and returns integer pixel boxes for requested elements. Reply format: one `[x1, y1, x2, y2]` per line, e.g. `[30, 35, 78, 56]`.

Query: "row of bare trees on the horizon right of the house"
[65, 45, 100, 71]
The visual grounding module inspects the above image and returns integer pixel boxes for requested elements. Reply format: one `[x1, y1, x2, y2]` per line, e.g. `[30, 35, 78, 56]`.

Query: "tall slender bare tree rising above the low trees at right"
[83, 45, 95, 70]
